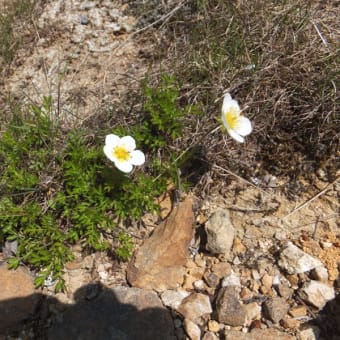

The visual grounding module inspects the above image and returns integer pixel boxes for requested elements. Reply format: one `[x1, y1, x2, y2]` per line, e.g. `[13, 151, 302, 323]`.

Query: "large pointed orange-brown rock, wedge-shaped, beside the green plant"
[127, 196, 194, 290]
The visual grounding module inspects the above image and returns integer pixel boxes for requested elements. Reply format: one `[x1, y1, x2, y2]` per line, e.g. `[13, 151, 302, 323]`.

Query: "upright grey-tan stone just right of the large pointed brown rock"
[205, 209, 235, 257]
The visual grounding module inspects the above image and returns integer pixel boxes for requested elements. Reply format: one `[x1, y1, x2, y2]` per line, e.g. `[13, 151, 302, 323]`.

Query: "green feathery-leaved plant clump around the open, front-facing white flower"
[0, 75, 197, 290]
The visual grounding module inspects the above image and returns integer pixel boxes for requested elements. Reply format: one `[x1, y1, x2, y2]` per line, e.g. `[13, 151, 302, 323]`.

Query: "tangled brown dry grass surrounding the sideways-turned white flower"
[129, 0, 340, 191]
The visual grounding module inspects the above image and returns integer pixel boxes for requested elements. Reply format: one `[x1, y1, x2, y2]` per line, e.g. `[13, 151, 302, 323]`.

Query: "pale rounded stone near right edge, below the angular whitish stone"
[301, 280, 335, 309]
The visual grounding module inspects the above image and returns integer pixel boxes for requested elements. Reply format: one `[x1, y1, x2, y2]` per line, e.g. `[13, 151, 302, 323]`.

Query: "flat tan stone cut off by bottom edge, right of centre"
[224, 328, 296, 340]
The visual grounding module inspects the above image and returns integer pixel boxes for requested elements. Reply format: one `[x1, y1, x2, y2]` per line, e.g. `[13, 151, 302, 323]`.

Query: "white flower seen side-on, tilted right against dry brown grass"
[222, 93, 252, 143]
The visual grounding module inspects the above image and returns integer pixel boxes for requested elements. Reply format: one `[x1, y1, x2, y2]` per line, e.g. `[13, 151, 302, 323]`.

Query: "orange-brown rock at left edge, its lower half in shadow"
[0, 265, 41, 334]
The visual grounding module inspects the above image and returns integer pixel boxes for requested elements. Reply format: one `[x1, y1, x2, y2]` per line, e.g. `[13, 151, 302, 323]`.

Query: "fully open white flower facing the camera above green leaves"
[104, 134, 145, 173]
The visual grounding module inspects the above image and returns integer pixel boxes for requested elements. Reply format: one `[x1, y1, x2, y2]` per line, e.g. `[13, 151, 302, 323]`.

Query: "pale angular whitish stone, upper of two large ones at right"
[278, 242, 322, 274]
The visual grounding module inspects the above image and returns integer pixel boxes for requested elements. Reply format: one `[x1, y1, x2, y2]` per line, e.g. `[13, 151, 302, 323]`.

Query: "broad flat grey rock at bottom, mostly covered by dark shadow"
[48, 287, 175, 340]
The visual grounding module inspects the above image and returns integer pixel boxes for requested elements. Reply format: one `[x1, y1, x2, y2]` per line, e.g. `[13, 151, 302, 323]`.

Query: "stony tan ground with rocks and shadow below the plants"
[0, 178, 340, 340]
